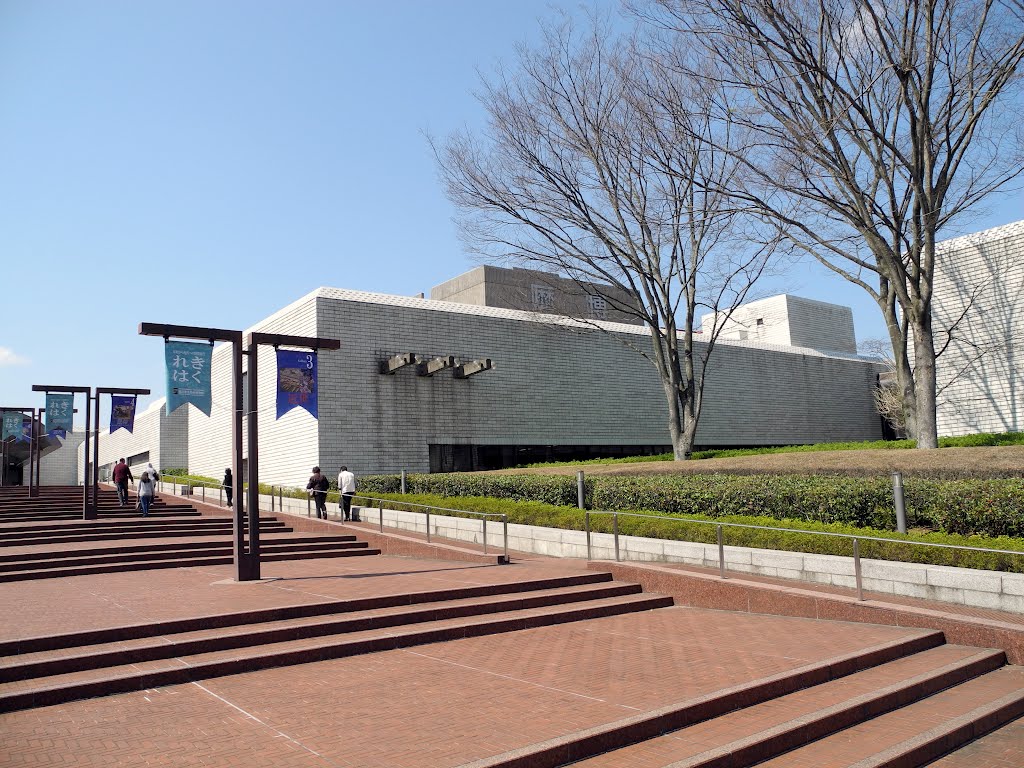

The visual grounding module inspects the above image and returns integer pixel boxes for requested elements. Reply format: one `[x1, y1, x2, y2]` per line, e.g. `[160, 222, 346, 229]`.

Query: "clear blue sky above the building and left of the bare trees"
[0, 0, 1024, 422]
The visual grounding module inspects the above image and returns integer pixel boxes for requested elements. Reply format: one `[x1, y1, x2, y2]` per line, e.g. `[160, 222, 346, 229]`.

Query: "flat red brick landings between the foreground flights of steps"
[0, 557, 1024, 768]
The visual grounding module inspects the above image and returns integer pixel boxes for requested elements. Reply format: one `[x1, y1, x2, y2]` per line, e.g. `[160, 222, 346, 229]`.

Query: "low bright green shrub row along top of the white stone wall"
[364, 494, 1024, 573]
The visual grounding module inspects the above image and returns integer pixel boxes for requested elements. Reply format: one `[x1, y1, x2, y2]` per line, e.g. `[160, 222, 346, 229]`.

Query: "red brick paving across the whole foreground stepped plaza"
[0, 495, 1024, 768]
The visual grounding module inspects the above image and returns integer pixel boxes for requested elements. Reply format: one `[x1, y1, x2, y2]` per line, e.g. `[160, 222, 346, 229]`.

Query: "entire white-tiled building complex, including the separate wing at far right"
[54, 221, 1024, 484]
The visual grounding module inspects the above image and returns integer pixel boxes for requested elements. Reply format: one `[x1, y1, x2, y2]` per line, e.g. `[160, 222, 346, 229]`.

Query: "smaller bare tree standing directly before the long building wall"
[435, 24, 772, 460]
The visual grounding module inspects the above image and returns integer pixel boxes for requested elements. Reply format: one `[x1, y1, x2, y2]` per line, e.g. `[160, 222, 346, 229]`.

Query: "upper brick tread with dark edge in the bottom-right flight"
[573, 645, 1006, 768]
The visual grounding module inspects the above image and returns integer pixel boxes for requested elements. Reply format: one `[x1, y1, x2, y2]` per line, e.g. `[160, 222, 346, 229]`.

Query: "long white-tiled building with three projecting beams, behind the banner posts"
[75, 269, 882, 485]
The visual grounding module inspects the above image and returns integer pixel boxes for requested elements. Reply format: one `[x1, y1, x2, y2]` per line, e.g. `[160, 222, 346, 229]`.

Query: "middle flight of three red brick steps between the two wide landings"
[0, 572, 672, 712]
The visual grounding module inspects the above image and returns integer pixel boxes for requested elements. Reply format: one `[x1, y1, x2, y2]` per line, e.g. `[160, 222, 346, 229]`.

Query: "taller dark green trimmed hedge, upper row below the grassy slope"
[359, 474, 1024, 538]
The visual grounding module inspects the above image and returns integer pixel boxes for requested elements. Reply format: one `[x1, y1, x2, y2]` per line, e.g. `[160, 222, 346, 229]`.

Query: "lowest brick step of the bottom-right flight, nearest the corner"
[759, 667, 1024, 768]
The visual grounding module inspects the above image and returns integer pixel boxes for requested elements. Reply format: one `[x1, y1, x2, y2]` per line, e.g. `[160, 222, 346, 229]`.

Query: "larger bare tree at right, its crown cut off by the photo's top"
[634, 0, 1024, 447]
